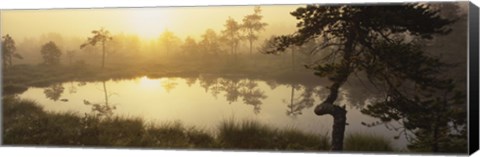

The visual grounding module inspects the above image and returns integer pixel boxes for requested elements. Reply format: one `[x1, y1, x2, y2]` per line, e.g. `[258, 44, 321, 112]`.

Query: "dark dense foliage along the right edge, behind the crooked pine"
[362, 3, 467, 153]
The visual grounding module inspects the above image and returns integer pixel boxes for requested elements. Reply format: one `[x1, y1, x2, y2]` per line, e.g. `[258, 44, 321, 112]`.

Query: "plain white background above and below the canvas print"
[0, 0, 480, 157]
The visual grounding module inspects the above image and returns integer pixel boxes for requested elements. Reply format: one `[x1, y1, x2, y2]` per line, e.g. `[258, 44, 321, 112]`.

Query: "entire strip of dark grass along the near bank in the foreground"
[2, 96, 392, 151]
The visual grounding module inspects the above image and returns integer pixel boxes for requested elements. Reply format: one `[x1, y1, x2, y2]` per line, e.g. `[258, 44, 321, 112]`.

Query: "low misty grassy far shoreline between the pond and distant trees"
[2, 64, 322, 95]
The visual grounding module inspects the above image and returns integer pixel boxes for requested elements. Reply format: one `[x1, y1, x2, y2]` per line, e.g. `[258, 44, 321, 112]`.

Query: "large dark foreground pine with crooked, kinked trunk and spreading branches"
[269, 3, 453, 151]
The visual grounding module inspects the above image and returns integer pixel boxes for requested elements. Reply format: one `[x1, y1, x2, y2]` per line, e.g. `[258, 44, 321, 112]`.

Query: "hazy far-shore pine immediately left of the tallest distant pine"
[222, 17, 242, 55]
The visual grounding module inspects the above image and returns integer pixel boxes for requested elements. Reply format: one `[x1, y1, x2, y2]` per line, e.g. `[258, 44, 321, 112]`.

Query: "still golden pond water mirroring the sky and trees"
[20, 76, 407, 149]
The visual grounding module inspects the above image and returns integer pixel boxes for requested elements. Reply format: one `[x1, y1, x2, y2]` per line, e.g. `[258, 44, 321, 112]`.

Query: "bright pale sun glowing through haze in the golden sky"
[126, 8, 169, 40]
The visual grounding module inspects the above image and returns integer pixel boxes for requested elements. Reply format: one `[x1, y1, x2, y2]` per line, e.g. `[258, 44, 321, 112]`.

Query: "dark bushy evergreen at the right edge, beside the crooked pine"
[362, 3, 468, 153]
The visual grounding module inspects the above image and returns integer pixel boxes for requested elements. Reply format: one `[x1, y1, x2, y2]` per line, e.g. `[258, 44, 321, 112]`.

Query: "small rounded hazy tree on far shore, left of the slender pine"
[40, 41, 62, 65]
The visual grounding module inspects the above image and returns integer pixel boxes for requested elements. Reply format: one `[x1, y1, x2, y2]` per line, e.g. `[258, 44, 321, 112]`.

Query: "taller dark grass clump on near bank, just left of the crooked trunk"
[217, 119, 330, 151]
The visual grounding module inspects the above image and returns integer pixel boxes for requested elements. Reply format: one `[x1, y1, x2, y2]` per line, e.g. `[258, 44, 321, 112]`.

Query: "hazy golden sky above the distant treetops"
[1, 5, 299, 39]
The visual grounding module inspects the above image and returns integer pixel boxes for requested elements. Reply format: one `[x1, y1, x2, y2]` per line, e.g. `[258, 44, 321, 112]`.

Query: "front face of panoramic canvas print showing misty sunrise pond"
[0, 2, 468, 154]
